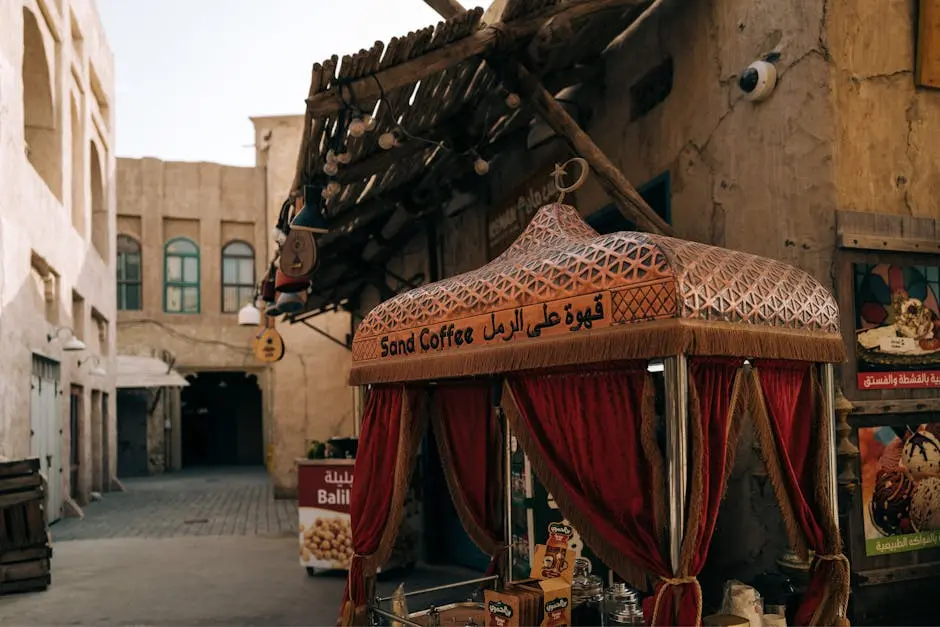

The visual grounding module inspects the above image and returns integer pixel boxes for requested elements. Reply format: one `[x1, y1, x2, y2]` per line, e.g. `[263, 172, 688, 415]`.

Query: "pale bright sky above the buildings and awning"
[97, 0, 440, 165]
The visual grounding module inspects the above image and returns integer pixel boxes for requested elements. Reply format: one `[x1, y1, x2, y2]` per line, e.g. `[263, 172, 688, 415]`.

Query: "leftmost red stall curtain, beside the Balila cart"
[343, 386, 404, 623]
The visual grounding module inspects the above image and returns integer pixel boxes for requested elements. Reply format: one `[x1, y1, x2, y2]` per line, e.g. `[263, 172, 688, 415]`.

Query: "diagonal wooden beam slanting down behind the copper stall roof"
[506, 62, 675, 235]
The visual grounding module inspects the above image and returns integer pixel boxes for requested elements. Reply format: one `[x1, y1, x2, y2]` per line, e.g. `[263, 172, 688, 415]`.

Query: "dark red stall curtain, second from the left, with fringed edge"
[431, 382, 506, 560]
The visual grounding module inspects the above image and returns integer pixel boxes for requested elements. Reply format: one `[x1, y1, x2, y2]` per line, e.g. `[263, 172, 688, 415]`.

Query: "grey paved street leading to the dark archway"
[0, 469, 482, 626]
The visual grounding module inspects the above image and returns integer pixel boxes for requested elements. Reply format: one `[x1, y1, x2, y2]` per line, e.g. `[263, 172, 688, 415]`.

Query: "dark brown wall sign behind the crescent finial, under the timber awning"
[486, 147, 571, 259]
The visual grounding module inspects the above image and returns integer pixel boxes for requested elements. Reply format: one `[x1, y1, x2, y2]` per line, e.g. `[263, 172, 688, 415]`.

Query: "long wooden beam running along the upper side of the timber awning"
[307, 0, 646, 117]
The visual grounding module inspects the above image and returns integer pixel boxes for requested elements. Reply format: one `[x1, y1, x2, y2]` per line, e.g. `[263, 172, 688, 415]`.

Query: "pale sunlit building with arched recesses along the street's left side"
[0, 0, 116, 520]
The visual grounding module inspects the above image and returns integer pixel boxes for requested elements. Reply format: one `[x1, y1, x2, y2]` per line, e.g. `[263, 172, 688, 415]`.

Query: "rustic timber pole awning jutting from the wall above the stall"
[282, 0, 652, 319]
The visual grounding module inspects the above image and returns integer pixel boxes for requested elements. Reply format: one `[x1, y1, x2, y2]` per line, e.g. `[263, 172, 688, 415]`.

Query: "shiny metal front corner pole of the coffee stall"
[664, 355, 689, 573]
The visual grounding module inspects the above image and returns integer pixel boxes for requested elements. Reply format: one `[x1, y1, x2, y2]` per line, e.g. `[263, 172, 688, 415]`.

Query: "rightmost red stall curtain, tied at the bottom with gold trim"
[751, 361, 849, 625]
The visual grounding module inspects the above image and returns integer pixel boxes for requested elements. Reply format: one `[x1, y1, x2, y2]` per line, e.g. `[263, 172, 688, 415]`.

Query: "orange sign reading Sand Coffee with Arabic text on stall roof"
[379, 291, 611, 359]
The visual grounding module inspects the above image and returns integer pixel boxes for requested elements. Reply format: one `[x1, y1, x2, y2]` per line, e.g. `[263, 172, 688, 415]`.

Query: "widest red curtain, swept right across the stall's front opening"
[503, 363, 671, 600]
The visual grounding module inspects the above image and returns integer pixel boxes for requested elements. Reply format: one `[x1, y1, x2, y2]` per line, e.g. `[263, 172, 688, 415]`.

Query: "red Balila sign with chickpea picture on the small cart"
[297, 461, 353, 569]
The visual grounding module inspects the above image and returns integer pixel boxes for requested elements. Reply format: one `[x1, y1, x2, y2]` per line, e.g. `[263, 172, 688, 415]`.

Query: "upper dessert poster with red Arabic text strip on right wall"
[854, 264, 940, 390]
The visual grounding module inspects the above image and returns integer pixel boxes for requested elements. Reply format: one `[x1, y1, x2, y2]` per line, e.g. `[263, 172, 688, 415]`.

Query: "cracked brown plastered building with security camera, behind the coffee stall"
[282, 0, 940, 624]
